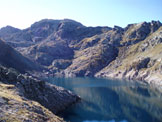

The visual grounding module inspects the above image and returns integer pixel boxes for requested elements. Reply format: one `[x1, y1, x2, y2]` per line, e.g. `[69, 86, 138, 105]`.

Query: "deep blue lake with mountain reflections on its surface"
[49, 78, 162, 122]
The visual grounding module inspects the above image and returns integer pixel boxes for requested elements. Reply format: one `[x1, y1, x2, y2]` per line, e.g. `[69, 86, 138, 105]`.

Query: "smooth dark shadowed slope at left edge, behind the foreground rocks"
[0, 39, 41, 73]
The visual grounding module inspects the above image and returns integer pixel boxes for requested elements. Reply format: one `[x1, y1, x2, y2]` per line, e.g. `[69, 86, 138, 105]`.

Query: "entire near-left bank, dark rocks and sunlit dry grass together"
[0, 66, 80, 122]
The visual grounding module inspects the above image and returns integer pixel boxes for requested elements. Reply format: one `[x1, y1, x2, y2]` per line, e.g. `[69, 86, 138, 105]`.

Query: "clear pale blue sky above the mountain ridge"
[0, 0, 162, 29]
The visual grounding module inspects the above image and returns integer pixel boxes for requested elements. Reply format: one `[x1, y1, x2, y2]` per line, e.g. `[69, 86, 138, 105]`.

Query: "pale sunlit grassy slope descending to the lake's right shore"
[95, 27, 162, 86]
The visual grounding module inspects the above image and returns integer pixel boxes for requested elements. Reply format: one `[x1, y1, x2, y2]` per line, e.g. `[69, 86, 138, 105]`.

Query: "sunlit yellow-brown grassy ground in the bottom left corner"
[0, 82, 63, 122]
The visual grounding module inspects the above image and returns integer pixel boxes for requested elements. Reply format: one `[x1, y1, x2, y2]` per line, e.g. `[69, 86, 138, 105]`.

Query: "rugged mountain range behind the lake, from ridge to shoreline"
[0, 19, 162, 83]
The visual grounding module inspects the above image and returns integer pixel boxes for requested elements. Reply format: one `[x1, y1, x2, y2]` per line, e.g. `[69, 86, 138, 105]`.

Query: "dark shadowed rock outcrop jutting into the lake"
[0, 67, 79, 113]
